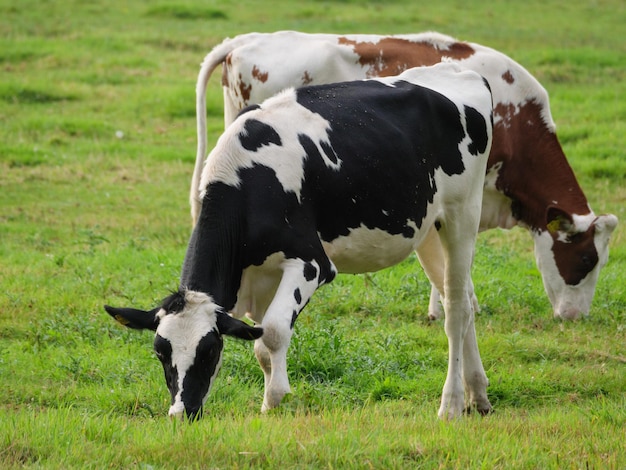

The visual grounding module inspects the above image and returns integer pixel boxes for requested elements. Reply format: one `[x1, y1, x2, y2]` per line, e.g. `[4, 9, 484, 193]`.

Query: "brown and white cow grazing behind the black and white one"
[190, 31, 617, 319]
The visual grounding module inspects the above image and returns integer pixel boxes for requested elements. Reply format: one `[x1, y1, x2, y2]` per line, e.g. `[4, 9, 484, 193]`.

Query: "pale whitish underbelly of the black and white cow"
[323, 226, 424, 274]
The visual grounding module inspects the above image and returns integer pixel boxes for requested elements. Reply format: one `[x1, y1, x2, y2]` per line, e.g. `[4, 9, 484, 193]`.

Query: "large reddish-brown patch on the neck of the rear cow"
[488, 102, 590, 231]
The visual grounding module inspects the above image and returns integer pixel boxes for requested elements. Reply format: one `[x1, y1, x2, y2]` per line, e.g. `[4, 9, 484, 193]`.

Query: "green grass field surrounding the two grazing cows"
[0, 0, 626, 469]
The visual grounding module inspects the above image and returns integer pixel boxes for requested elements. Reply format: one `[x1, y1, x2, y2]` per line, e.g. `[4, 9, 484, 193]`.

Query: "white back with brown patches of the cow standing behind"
[223, 31, 554, 130]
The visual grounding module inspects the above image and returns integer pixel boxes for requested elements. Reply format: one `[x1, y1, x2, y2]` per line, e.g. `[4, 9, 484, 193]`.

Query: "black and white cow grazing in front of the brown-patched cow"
[106, 64, 492, 419]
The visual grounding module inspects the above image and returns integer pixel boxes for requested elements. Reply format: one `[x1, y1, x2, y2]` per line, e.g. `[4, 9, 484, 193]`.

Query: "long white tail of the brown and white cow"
[189, 35, 248, 226]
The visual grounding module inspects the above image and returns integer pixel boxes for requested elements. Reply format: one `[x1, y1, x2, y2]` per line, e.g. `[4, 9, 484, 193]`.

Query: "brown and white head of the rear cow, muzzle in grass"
[533, 207, 617, 320]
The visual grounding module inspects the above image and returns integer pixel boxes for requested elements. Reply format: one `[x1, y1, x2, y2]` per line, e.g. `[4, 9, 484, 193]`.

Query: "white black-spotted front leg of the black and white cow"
[254, 259, 323, 411]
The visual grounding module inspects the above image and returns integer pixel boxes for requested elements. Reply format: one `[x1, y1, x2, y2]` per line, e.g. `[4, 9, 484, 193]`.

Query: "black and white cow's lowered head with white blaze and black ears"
[104, 290, 263, 420]
